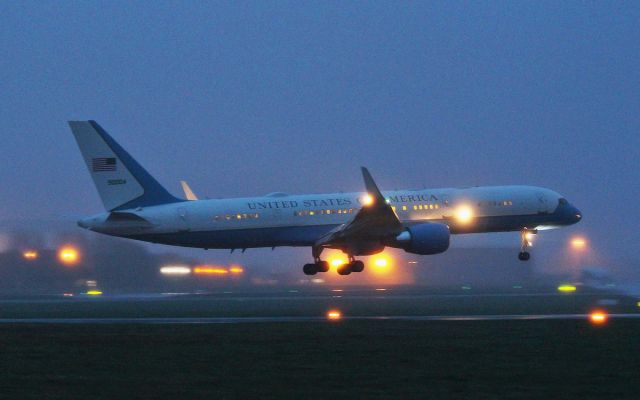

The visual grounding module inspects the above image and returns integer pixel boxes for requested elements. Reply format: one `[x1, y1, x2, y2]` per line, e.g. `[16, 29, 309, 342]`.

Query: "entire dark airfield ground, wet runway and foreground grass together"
[0, 289, 640, 400]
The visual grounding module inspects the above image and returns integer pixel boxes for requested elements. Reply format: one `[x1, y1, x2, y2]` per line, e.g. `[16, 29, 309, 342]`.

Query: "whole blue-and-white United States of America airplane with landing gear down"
[69, 120, 582, 275]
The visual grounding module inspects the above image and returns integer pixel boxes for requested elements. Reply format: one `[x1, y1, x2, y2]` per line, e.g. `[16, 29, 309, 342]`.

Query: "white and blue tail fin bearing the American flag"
[69, 121, 182, 211]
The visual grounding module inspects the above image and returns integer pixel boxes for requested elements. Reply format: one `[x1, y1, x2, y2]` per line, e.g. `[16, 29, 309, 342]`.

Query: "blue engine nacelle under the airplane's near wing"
[395, 223, 450, 256]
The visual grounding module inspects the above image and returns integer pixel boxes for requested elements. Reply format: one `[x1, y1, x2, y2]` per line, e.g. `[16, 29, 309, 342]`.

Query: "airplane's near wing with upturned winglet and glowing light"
[316, 167, 403, 247]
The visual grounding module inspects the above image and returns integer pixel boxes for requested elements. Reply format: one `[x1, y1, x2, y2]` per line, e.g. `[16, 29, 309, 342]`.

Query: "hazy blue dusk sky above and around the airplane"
[0, 1, 640, 264]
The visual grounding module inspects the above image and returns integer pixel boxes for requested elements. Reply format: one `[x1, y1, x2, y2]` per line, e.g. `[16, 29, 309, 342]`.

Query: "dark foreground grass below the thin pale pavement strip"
[0, 320, 640, 399]
